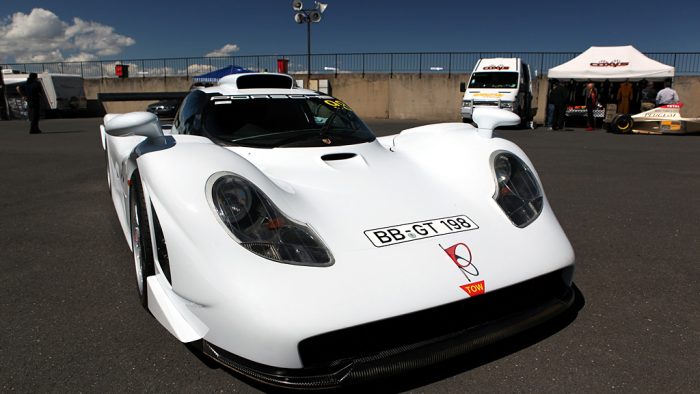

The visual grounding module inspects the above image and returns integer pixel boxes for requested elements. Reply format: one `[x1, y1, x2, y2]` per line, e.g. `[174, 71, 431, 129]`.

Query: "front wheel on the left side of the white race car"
[129, 173, 155, 309]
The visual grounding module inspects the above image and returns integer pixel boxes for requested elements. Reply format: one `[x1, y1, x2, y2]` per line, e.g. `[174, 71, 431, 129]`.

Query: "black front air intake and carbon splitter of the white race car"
[202, 267, 574, 390]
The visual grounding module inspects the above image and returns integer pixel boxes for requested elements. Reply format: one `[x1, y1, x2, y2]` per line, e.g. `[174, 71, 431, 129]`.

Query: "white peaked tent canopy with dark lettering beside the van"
[547, 45, 674, 81]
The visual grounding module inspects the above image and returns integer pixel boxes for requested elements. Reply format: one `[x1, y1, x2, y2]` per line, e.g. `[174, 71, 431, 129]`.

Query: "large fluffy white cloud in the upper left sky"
[0, 8, 136, 62]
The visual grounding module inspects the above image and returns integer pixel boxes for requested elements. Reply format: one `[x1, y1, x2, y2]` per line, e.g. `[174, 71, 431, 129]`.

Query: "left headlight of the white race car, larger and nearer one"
[207, 172, 333, 267]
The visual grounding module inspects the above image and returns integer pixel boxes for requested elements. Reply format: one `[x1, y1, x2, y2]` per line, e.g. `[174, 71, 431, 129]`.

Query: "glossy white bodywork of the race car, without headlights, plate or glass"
[102, 74, 574, 376]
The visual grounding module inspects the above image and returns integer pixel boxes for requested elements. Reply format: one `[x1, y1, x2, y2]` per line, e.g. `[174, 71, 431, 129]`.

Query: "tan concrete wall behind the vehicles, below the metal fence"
[85, 74, 700, 124]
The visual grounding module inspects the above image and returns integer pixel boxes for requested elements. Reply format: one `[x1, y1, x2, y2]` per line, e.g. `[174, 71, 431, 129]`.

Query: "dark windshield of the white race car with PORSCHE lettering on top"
[202, 94, 375, 148]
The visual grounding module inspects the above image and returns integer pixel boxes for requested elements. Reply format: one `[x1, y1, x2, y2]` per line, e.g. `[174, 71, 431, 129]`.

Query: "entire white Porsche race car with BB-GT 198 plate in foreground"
[101, 73, 575, 389]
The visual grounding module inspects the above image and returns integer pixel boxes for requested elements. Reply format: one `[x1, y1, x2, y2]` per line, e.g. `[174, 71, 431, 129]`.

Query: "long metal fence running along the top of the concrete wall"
[0, 52, 700, 78]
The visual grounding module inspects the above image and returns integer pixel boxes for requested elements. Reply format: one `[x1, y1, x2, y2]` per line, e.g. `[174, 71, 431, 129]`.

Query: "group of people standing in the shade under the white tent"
[546, 79, 679, 131]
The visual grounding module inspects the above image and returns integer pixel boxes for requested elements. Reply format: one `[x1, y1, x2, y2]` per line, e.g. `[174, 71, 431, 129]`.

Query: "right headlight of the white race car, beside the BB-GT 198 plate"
[493, 152, 544, 227]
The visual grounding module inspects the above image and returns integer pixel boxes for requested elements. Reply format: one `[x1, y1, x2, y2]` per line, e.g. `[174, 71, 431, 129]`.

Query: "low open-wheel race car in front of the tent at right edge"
[610, 104, 700, 134]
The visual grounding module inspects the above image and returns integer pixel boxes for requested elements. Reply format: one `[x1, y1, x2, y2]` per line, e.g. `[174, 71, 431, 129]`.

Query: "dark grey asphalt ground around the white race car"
[0, 119, 700, 393]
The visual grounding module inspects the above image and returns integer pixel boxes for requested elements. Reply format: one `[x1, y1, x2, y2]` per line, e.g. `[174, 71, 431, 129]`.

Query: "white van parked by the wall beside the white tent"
[460, 58, 534, 125]
